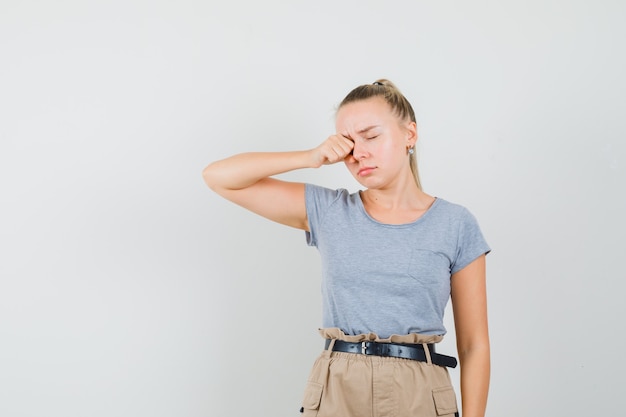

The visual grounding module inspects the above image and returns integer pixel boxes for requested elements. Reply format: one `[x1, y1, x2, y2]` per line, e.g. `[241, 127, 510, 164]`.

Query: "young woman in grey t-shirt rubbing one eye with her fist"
[203, 80, 490, 417]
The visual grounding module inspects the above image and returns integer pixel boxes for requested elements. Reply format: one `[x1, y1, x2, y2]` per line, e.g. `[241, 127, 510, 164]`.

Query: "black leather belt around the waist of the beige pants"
[324, 339, 456, 368]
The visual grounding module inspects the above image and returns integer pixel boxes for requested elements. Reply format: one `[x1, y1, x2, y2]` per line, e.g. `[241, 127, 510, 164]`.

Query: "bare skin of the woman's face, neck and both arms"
[203, 97, 490, 417]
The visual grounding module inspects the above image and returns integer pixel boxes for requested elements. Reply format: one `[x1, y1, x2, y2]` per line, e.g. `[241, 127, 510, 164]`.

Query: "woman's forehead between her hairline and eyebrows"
[335, 97, 396, 131]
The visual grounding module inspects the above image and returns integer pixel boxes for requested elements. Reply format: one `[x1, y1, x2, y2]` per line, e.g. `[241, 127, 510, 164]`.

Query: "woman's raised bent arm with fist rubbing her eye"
[202, 135, 354, 230]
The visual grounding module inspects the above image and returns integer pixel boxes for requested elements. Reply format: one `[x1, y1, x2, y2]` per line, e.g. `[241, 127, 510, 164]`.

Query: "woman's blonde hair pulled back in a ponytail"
[338, 79, 422, 190]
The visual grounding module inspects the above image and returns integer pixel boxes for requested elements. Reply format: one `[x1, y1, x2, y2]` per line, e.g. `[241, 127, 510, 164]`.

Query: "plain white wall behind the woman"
[0, 0, 626, 417]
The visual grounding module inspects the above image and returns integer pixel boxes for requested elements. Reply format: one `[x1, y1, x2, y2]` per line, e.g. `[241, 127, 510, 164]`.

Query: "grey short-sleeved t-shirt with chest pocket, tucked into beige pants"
[306, 184, 490, 338]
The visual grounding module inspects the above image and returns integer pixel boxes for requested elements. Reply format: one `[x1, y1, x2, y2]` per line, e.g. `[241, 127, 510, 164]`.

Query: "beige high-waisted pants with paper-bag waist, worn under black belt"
[302, 328, 458, 417]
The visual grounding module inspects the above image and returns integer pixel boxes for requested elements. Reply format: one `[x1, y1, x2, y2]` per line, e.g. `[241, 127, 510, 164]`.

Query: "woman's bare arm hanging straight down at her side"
[451, 255, 490, 417]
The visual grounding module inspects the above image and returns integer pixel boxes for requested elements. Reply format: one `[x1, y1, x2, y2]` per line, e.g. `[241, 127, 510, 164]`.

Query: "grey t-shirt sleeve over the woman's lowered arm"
[450, 209, 491, 274]
